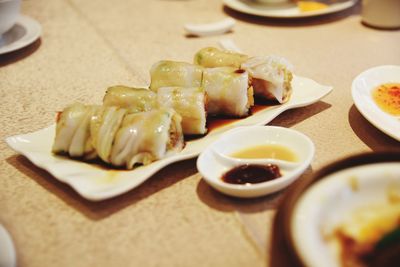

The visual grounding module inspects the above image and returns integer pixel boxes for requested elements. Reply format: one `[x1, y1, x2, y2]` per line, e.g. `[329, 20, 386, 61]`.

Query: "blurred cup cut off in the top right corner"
[361, 0, 400, 29]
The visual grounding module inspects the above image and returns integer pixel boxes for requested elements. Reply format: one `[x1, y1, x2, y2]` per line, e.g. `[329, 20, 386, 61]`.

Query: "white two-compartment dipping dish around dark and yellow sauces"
[197, 126, 315, 198]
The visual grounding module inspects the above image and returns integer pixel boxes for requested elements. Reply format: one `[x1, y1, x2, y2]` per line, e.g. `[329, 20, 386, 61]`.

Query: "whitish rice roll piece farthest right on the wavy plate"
[241, 56, 293, 103]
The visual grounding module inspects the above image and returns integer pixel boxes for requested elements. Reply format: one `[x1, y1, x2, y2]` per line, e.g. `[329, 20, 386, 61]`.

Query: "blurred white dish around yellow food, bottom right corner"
[290, 162, 400, 267]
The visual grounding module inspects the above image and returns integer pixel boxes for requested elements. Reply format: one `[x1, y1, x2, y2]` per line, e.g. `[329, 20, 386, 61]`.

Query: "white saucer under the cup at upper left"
[0, 15, 42, 55]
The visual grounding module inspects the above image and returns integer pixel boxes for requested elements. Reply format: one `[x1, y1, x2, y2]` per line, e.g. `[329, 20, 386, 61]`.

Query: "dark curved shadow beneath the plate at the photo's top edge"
[223, 0, 361, 27]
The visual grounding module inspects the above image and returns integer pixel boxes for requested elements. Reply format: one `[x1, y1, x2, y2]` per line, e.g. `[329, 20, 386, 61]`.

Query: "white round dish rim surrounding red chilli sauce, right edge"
[351, 65, 400, 141]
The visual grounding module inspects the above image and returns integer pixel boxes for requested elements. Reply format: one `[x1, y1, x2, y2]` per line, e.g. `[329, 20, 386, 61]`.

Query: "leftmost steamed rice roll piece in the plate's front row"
[52, 103, 98, 158]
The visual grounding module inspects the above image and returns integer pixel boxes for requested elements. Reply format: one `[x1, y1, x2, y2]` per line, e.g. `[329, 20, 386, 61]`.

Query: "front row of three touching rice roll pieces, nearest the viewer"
[52, 103, 184, 169]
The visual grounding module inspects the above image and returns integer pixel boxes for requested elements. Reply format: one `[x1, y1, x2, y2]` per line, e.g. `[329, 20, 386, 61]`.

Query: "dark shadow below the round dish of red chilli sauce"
[348, 105, 400, 151]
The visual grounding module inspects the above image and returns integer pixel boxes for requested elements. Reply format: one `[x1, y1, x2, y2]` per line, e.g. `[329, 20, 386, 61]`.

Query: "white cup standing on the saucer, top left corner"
[0, 0, 21, 37]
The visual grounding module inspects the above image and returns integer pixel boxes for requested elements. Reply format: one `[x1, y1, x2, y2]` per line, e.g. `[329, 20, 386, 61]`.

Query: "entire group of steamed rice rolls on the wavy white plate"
[52, 47, 292, 169]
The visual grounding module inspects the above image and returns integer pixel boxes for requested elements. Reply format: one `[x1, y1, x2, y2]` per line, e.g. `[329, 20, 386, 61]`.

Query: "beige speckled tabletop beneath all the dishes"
[0, 0, 400, 266]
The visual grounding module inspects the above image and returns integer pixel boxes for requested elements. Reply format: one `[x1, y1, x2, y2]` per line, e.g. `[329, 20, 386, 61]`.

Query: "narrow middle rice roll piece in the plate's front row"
[90, 106, 127, 163]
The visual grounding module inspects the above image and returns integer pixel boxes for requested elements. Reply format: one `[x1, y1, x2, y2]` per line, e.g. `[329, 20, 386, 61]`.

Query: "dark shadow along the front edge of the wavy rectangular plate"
[6, 155, 197, 220]
